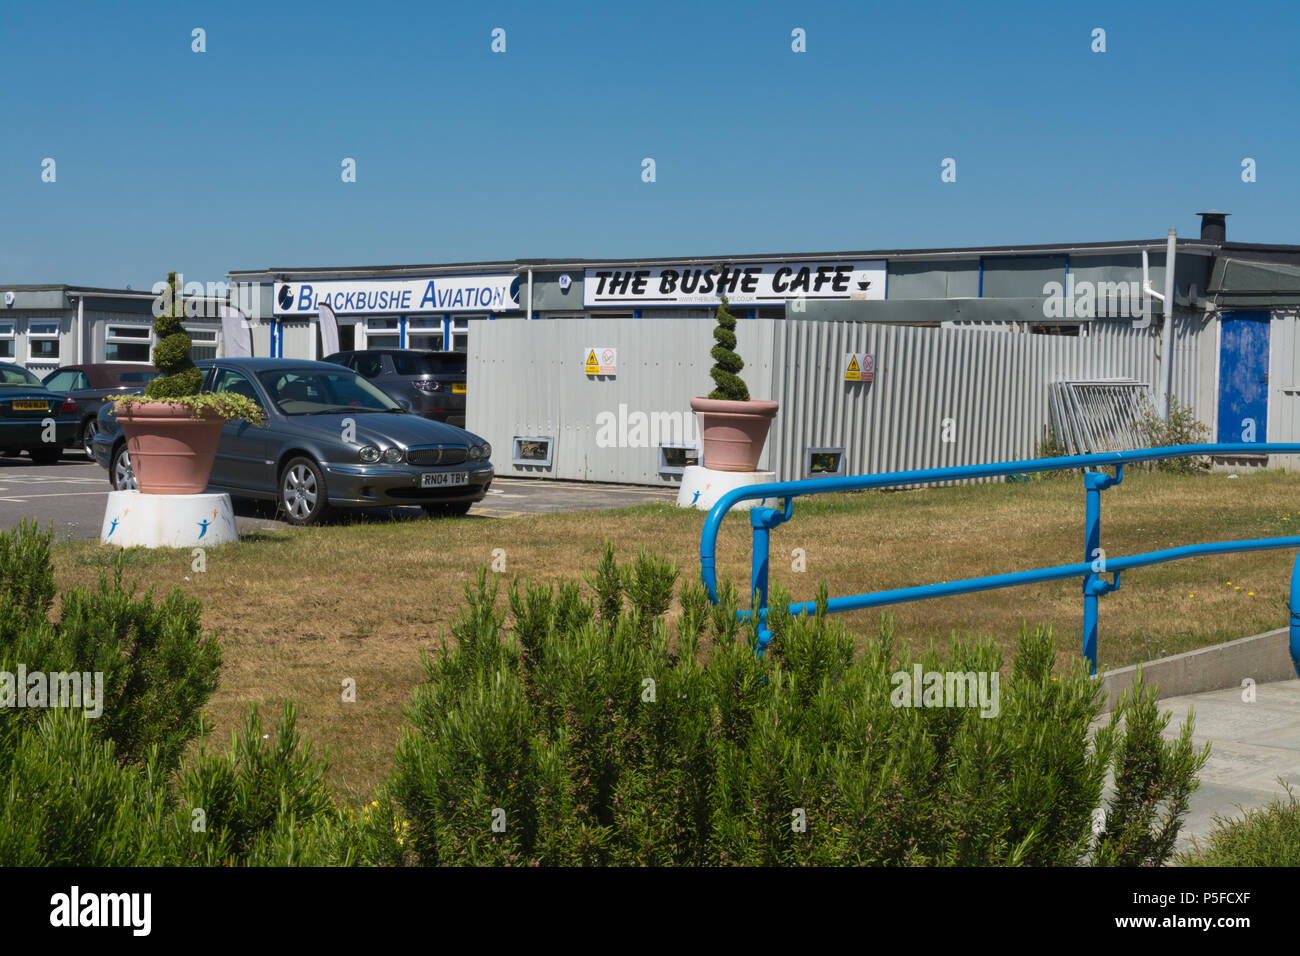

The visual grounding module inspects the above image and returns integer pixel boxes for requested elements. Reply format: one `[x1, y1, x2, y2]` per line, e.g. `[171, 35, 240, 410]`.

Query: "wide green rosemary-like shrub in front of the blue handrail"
[393, 548, 1204, 865]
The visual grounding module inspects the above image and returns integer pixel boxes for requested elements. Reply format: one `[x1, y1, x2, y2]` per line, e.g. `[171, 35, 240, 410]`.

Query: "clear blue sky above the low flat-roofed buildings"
[0, 0, 1300, 289]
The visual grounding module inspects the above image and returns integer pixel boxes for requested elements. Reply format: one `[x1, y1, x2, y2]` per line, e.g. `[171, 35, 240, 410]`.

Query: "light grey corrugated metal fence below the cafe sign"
[467, 319, 1197, 484]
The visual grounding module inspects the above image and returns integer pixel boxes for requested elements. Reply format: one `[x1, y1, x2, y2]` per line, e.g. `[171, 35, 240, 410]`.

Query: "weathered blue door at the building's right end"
[1218, 312, 1269, 442]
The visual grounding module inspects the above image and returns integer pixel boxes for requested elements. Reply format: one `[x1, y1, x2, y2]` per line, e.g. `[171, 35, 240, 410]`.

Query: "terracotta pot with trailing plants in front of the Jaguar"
[117, 402, 226, 494]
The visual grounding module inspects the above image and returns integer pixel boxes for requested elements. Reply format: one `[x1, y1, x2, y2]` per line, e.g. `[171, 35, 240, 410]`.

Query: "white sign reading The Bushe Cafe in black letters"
[582, 259, 885, 307]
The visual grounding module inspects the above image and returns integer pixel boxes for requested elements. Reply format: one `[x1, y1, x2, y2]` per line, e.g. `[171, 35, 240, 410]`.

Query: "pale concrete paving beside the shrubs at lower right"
[1160, 678, 1300, 849]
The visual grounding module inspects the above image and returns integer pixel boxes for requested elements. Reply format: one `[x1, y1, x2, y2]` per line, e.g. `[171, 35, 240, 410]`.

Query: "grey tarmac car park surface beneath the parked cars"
[0, 451, 676, 540]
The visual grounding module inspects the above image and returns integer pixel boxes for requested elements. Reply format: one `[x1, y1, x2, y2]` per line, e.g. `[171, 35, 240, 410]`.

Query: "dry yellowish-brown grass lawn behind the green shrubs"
[45, 472, 1300, 800]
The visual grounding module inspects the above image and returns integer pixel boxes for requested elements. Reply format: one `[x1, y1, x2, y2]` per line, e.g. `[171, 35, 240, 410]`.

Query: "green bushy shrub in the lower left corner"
[0, 522, 371, 866]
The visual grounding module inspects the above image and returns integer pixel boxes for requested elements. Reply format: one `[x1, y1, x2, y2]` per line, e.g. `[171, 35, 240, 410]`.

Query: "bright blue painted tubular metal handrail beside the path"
[699, 442, 1300, 676]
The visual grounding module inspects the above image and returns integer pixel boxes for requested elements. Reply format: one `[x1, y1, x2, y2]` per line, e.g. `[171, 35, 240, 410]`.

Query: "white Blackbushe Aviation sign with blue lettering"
[274, 273, 519, 315]
